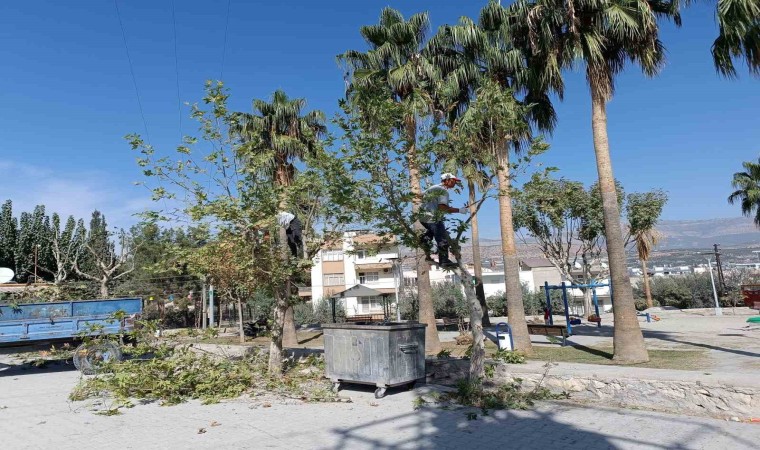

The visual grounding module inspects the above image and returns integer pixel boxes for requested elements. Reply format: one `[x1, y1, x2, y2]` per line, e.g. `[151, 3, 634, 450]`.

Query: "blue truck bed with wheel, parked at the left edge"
[0, 298, 143, 373]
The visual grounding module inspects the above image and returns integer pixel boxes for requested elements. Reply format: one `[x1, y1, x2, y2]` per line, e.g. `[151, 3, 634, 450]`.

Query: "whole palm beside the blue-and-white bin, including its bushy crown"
[432, 1, 562, 352]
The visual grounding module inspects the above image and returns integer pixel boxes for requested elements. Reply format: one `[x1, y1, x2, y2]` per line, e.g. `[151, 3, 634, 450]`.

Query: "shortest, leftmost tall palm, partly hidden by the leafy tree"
[231, 90, 326, 370]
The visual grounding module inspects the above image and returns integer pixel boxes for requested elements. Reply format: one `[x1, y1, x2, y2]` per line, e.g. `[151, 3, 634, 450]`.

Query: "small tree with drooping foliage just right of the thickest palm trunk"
[625, 191, 668, 308]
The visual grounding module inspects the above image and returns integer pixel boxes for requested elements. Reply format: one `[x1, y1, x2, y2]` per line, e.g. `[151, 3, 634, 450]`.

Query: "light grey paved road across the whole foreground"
[0, 364, 760, 450]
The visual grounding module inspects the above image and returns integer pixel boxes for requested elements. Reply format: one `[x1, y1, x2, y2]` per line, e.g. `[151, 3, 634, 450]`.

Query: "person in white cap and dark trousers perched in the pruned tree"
[420, 173, 467, 268]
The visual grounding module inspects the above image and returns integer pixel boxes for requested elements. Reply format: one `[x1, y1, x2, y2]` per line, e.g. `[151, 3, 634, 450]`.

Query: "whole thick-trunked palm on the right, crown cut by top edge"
[510, 0, 674, 363]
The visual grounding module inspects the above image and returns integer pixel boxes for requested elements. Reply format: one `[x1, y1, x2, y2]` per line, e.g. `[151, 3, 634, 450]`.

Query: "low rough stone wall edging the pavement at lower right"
[427, 359, 760, 419]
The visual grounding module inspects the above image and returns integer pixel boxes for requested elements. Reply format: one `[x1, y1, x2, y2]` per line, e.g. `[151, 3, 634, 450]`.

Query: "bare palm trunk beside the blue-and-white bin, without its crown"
[496, 149, 533, 353]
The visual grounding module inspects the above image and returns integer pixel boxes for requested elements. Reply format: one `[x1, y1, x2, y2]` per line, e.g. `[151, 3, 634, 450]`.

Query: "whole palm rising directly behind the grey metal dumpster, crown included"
[338, 7, 440, 353]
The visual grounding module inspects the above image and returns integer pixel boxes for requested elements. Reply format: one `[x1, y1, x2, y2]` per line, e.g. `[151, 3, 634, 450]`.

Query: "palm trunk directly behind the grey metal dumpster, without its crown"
[405, 117, 441, 354]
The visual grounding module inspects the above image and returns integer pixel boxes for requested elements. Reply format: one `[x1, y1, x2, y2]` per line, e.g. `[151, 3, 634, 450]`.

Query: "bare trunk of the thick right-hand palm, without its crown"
[591, 87, 649, 364]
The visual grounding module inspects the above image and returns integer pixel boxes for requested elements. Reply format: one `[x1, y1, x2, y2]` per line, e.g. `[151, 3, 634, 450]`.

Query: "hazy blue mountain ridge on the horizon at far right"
[657, 217, 760, 250]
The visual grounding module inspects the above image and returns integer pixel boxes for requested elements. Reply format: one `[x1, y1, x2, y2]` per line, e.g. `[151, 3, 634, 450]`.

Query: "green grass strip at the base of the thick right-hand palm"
[528, 345, 709, 370]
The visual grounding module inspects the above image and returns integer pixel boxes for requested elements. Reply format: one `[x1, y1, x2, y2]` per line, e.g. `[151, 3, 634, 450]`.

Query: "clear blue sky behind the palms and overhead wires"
[0, 0, 760, 237]
